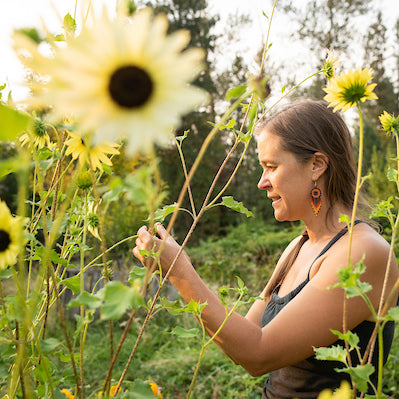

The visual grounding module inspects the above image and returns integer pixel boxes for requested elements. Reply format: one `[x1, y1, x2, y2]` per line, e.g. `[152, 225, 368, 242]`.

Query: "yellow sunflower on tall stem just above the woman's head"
[323, 68, 378, 112]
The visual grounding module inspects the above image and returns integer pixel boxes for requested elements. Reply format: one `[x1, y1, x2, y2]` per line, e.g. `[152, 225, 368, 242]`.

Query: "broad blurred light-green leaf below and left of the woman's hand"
[101, 281, 145, 320]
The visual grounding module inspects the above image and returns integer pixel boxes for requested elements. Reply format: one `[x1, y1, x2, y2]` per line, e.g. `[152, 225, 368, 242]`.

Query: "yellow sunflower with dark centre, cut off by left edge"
[0, 201, 23, 270]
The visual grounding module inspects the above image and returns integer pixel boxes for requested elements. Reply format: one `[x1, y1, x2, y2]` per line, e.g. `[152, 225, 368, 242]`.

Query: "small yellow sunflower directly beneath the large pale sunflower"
[65, 132, 119, 170]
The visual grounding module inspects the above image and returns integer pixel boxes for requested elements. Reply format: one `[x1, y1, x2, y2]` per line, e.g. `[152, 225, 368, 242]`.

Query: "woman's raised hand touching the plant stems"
[133, 223, 191, 275]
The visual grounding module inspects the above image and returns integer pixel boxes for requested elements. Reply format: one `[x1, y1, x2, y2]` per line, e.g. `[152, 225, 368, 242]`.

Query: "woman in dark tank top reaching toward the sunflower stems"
[133, 101, 399, 399]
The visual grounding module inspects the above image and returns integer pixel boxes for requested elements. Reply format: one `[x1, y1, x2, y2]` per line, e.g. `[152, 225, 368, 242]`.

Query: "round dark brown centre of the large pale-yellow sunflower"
[109, 65, 153, 108]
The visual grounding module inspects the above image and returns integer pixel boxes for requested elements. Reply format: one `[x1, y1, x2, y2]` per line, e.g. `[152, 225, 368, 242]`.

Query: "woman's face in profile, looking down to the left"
[258, 130, 314, 222]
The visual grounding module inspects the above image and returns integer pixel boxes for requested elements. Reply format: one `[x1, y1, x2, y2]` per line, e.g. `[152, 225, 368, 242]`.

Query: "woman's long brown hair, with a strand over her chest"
[256, 100, 366, 297]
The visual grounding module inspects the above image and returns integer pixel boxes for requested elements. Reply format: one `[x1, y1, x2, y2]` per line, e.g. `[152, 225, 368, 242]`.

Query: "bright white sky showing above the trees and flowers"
[0, 0, 399, 100]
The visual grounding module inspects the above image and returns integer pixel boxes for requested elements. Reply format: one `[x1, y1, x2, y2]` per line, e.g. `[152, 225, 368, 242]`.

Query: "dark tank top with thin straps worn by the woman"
[262, 225, 395, 399]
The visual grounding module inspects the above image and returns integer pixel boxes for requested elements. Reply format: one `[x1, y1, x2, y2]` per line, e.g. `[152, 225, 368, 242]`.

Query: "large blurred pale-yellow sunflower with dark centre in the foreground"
[15, 8, 206, 152]
